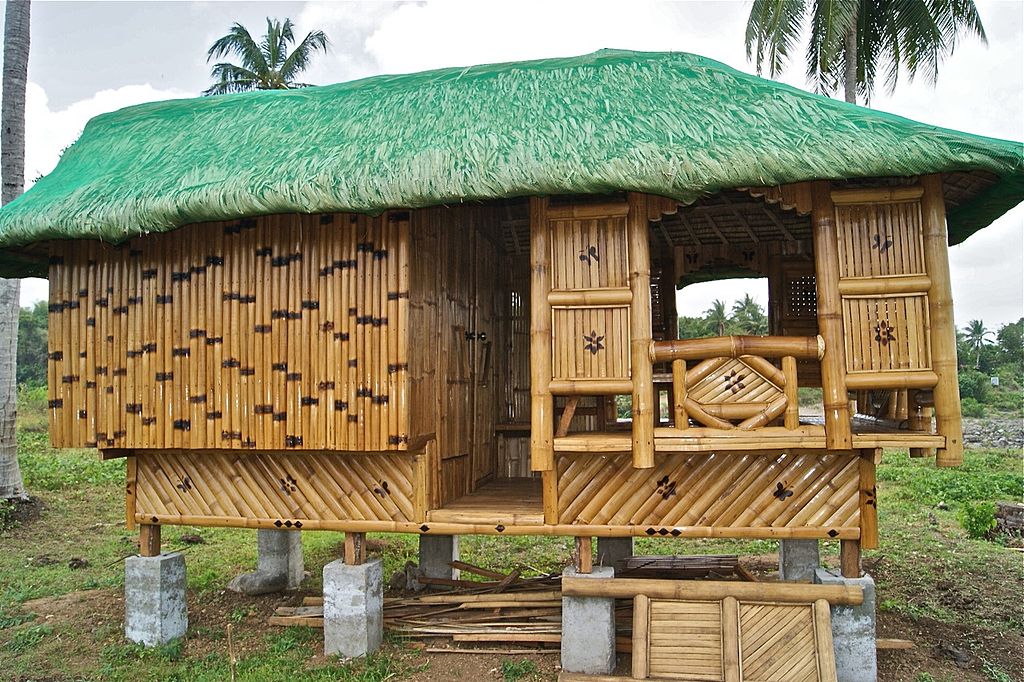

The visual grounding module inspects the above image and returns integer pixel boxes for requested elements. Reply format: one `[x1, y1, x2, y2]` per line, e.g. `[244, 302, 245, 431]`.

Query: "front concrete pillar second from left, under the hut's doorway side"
[324, 557, 384, 658]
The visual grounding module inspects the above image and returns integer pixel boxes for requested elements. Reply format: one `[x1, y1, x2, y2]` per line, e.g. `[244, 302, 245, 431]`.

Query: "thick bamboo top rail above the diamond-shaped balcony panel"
[650, 336, 825, 363]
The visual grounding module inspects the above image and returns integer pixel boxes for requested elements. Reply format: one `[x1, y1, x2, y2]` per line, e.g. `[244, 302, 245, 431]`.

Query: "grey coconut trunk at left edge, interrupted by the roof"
[0, 0, 31, 499]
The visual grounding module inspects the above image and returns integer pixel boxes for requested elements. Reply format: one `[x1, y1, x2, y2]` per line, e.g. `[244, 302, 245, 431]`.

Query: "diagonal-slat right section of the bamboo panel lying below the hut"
[739, 602, 819, 682]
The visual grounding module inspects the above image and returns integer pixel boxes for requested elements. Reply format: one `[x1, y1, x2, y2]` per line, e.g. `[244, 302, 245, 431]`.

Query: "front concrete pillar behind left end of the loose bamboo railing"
[562, 566, 615, 675]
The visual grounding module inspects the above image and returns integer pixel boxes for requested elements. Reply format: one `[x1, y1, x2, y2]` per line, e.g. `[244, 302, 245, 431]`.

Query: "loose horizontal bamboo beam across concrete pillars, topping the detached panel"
[562, 578, 864, 606]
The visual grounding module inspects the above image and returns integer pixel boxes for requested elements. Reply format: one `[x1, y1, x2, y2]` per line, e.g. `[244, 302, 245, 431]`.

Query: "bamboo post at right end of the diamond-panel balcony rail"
[811, 181, 853, 450]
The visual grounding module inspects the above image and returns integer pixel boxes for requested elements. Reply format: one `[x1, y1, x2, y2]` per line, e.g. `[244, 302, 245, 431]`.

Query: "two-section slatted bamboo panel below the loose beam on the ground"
[633, 595, 837, 682]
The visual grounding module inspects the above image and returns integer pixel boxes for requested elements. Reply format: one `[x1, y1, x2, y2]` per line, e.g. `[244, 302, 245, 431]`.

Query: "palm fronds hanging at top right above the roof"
[745, 0, 987, 103]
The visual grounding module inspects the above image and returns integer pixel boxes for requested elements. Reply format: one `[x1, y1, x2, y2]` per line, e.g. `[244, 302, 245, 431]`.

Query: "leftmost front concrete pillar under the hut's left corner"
[125, 552, 188, 646]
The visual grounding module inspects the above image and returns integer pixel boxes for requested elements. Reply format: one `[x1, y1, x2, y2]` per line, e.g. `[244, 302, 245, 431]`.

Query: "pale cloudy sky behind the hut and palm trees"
[0, 0, 1024, 329]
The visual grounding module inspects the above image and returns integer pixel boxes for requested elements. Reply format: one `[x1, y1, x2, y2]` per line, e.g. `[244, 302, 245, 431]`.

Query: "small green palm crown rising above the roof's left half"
[203, 17, 330, 95]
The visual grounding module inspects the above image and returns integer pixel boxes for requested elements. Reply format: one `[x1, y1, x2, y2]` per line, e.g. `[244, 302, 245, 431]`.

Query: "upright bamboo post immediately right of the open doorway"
[529, 197, 555, 471]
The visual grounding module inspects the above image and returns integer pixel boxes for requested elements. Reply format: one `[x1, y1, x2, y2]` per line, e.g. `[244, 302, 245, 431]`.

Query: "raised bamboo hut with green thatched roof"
[0, 50, 1024, 667]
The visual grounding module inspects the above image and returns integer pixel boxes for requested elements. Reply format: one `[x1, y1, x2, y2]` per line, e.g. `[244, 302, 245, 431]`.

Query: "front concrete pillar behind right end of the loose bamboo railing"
[814, 568, 878, 682]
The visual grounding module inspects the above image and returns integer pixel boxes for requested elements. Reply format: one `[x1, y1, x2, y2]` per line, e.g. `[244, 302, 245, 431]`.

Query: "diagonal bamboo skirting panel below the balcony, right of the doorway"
[558, 452, 860, 535]
